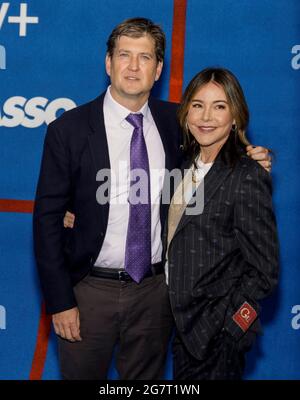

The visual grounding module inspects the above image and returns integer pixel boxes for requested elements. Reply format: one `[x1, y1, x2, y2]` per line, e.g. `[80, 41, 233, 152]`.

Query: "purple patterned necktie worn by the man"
[125, 114, 151, 283]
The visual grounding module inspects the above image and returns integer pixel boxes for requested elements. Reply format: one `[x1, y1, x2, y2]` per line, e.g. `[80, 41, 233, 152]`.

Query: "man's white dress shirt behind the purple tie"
[95, 87, 165, 268]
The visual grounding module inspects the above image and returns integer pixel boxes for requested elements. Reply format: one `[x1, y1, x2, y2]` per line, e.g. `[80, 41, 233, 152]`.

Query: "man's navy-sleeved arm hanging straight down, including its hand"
[33, 124, 79, 339]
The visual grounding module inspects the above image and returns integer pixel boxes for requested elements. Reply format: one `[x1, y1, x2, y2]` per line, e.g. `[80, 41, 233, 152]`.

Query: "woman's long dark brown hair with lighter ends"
[178, 68, 249, 167]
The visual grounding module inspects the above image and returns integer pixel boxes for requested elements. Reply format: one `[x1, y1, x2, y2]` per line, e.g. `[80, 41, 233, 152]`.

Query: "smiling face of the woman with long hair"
[186, 82, 235, 149]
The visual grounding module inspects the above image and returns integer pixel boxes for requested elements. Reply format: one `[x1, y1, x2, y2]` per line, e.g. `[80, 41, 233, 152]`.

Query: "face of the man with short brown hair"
[105, 35, 163, 108]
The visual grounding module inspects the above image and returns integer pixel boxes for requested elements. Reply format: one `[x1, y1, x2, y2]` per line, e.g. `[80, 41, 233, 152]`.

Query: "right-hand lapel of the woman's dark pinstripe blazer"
[173, 155, 232, 238]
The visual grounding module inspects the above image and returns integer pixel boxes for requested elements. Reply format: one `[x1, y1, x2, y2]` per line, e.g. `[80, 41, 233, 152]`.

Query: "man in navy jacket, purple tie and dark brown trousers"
[34, 18, 269, 379]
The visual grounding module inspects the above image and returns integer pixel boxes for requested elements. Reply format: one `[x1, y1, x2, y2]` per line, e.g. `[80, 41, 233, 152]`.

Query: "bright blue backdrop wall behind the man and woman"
[0, 0, 300, 379]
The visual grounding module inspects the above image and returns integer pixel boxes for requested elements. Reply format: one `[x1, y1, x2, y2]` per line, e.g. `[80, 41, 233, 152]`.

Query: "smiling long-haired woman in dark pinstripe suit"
[165, 68, 278, 379]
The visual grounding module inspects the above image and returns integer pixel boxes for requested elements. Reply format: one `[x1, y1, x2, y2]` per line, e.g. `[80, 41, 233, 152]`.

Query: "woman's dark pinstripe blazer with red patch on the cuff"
[164, 155, 278, 359]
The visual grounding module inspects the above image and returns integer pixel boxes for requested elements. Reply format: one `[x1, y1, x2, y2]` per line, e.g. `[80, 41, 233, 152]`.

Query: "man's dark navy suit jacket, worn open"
[33, 94, 181, 314]
